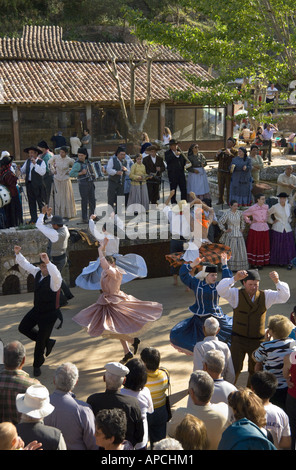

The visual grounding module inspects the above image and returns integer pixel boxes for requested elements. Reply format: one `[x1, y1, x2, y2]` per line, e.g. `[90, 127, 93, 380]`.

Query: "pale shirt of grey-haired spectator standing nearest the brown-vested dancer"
[193, 336, 235, 384]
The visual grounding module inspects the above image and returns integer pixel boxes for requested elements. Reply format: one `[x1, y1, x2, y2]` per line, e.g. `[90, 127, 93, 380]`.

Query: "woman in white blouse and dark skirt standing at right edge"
[268, 193, 296, 269]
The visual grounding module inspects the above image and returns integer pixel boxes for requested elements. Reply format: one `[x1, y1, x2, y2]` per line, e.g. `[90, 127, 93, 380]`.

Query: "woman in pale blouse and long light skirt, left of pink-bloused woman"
[218, 200, 249, 271]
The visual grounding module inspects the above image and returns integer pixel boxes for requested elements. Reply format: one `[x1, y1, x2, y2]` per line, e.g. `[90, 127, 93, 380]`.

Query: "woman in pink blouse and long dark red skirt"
[243, 194, 270, 269]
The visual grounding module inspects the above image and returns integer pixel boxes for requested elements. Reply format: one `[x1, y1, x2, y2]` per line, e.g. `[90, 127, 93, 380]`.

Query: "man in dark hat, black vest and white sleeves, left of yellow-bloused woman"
[106, 147, 128, 214]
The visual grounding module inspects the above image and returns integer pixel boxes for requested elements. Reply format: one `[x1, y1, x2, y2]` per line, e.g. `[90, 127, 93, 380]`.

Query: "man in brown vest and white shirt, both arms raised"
[217, 269, 290, 384]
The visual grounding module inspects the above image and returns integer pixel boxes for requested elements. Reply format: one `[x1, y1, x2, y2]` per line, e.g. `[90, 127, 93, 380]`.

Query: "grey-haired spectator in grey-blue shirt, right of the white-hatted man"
[44, 362, 97, 450]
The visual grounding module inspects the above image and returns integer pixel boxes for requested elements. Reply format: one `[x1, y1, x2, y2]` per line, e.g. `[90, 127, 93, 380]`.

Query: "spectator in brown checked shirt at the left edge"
[0, 341, 39, 424]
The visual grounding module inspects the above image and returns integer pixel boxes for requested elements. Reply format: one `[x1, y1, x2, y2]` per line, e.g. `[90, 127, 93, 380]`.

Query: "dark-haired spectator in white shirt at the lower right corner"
[251, 371, 291, 450]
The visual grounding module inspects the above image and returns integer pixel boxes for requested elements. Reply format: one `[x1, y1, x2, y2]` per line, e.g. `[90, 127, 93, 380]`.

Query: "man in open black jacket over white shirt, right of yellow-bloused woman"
[143, 145, 165, 204]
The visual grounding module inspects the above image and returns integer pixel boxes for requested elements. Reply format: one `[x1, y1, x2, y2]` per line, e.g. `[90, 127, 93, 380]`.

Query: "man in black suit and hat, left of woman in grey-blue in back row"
[165, 139, 187, 204]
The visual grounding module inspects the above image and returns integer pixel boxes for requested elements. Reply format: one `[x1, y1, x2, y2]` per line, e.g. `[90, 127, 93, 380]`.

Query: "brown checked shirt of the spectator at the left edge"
[0, 369, 40, 424]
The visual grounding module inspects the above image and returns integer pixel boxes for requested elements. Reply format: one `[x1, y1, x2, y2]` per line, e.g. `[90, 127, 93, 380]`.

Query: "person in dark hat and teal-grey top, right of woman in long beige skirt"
[69, 147, 96, 224]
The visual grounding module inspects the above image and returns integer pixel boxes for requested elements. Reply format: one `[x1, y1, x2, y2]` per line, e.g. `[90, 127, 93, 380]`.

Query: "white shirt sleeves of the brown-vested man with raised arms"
[216, 277, 290, 310]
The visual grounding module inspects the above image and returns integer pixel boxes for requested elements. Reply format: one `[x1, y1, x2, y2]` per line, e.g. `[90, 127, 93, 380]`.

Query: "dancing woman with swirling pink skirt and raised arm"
[73, 239, 163, 363]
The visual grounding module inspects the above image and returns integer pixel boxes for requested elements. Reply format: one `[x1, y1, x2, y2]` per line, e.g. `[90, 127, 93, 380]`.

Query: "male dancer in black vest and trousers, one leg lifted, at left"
[14, 246, 62, 377]
